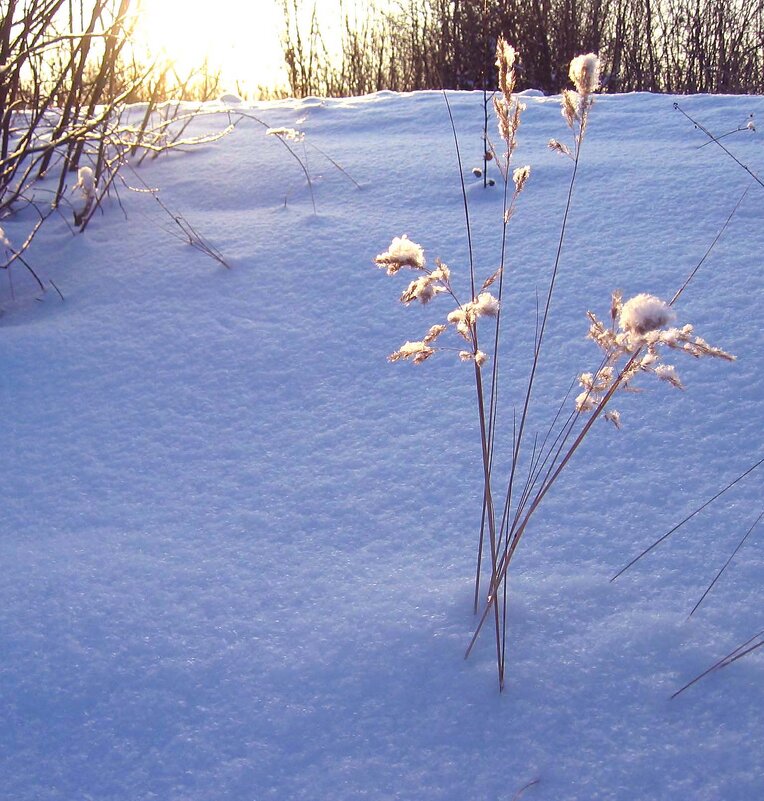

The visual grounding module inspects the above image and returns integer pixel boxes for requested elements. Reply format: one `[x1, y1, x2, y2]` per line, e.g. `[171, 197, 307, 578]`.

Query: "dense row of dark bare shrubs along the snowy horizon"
[282, 0, 764, 97]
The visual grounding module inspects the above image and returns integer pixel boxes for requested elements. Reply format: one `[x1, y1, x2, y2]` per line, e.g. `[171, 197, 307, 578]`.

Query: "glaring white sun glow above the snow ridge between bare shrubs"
[134, 0, 284, 92]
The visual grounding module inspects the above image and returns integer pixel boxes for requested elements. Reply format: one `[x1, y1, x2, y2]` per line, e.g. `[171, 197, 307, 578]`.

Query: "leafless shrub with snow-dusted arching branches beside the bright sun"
[0, 0, 239, 289]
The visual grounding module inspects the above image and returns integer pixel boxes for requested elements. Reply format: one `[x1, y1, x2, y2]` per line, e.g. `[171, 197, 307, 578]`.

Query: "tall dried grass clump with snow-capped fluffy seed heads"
[375, 40, 734, 688]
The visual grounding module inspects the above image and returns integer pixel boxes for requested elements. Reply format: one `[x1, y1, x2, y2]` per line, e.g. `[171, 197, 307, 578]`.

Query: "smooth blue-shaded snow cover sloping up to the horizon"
[0, 92, 764, 801]
